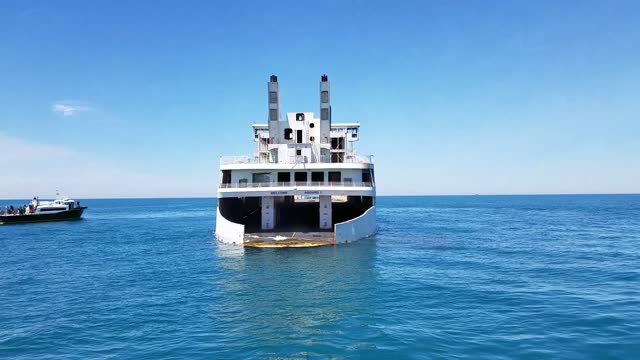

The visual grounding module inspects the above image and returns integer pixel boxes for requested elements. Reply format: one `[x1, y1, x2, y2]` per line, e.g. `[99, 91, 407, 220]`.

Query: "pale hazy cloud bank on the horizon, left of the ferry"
[0, 132, 216, 199]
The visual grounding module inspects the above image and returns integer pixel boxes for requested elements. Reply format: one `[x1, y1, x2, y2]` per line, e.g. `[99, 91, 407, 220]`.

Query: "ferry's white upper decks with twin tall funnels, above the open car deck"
[218, 75, 375, 197]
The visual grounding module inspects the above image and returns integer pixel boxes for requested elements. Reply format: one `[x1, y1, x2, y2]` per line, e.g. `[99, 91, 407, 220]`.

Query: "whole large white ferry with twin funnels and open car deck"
[216, 75, 376, 247]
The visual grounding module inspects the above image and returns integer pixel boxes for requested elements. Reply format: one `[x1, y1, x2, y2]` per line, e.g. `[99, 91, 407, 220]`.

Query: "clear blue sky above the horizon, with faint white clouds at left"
[0, 0, 640, 198]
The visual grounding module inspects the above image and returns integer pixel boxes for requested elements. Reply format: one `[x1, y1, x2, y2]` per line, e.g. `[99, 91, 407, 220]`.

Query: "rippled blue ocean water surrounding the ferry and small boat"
[0, 195, 640, 359]
